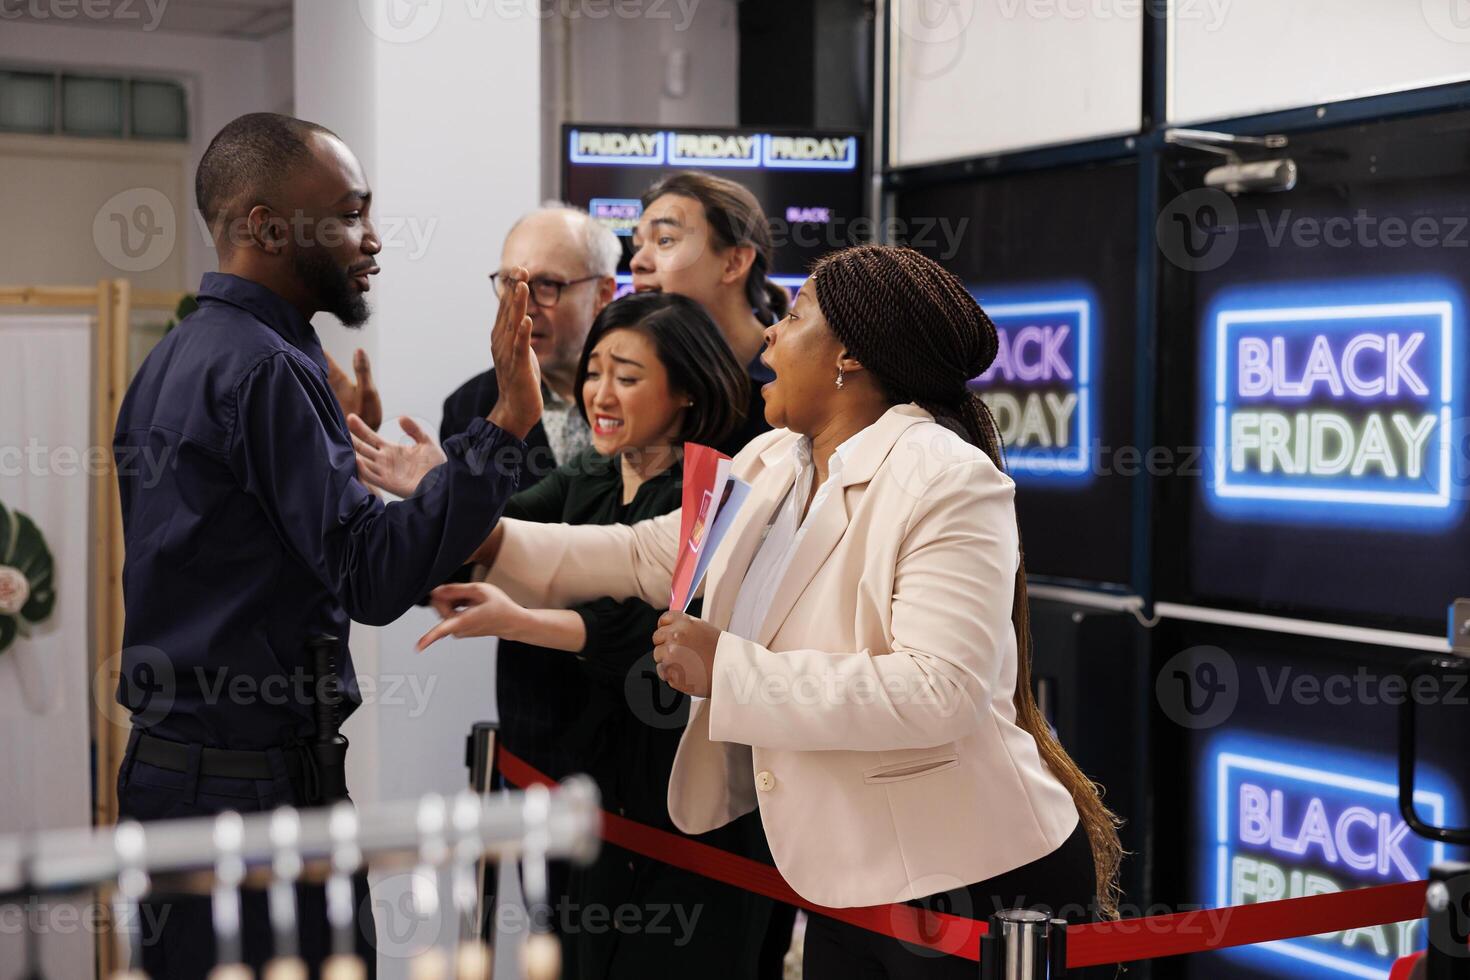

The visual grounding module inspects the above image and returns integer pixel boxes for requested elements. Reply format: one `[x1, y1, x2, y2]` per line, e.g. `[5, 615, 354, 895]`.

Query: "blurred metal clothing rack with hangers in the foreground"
[0, 776, 601, 980]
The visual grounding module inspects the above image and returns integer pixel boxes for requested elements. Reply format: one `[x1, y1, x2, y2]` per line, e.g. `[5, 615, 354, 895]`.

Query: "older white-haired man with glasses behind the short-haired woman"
[440, 204, 622, 478]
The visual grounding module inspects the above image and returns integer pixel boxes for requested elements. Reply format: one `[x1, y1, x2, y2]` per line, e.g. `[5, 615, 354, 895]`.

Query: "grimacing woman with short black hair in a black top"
[396, 294, 770, 980]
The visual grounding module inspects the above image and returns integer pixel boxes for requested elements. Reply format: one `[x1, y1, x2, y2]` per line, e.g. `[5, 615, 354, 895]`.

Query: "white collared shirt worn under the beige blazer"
[726, 429, 867, 641]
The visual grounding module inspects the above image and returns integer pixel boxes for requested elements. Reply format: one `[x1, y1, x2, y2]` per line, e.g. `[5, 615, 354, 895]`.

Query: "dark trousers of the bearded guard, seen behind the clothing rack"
[118, 745, 378, 980]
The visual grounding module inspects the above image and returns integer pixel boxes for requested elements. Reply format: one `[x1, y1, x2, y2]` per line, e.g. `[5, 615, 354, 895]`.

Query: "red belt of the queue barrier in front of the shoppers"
[498, 746, 1427, 968]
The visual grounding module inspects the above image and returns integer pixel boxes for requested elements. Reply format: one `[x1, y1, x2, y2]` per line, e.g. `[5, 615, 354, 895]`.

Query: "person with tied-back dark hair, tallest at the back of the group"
[629, 170, 791, 455]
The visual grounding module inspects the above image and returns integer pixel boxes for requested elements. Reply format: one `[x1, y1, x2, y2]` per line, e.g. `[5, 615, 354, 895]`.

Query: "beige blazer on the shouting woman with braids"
[488, 406, 1078, 914]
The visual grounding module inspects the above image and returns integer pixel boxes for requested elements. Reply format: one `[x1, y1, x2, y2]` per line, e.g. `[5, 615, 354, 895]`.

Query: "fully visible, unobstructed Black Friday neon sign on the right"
[1204, 281, 1461, 523]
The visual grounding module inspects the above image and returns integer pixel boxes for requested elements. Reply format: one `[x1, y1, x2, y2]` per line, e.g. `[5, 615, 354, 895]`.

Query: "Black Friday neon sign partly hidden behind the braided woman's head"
[970, 285, 1098, 483]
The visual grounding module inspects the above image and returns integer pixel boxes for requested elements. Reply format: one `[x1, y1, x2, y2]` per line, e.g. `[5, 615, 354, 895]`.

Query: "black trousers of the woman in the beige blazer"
[801, 824, 1097, 980]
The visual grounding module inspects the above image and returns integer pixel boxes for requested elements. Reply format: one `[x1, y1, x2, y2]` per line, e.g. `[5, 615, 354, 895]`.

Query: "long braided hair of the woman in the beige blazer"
[811, 245, 1123, 918]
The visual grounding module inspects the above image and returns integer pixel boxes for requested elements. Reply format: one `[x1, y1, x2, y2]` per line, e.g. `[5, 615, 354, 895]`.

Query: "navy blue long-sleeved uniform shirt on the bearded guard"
[113, 273, 525, 749]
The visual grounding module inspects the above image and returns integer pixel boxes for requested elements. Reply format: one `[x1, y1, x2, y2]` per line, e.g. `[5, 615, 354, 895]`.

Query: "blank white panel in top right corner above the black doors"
[1169, 0, 1470, 122]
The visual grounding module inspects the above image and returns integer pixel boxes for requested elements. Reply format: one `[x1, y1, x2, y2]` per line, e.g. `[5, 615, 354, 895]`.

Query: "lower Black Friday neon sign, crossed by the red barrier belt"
[1204, 738, 1448, 977]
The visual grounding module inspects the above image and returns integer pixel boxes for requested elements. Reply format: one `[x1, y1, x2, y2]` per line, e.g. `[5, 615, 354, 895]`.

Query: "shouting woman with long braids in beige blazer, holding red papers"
[429, 245, 1120, 980]
